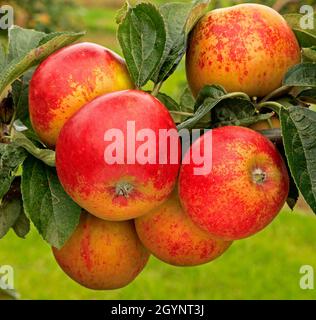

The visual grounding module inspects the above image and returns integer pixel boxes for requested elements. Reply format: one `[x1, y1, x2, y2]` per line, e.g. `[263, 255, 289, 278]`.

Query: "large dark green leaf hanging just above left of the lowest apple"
[22, 156, 81, 248]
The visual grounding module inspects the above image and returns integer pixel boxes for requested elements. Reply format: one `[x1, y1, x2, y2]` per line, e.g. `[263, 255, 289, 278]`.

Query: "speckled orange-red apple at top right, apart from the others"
[186, 3, 301, 97]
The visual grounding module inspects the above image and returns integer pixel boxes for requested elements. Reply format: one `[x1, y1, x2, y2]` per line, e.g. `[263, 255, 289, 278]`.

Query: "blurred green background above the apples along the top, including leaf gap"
[4, 0, 316, 99]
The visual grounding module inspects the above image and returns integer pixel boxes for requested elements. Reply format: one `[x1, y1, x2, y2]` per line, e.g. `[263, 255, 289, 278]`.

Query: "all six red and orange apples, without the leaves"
[29, 5, 300, 290]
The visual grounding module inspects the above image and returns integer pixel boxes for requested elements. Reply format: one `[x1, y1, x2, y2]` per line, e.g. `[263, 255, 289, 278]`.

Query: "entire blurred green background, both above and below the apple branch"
[0, 0, 316, 299]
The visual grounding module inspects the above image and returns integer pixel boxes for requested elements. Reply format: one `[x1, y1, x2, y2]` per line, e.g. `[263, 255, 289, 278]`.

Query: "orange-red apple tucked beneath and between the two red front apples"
[135, 192, 232, 266]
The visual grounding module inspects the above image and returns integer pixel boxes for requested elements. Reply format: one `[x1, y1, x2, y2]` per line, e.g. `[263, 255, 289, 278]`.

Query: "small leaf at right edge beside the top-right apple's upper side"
[284, 13, 316, 48]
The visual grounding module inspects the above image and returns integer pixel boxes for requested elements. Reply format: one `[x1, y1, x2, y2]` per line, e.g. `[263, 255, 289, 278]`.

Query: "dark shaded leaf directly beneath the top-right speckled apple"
[211, 97, 275, 128]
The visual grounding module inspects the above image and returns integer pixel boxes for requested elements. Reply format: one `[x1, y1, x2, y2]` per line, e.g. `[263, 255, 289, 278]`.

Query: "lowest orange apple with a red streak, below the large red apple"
[53, 212, 149, 290]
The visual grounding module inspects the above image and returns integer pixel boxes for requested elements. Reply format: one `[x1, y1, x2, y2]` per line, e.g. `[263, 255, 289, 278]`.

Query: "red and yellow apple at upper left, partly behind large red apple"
[29, 43, 134, 147]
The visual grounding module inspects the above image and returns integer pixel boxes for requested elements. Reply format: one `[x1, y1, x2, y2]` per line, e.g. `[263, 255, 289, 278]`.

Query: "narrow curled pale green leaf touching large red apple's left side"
[13, 131, 55, 167]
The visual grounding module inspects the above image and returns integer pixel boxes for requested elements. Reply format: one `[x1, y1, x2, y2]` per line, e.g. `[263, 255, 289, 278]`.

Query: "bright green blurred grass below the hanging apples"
[0, 210, 316, 300]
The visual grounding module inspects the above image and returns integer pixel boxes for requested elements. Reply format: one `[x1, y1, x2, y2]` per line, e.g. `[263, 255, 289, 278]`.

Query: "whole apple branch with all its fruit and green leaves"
[0, 0, 316, 290]
